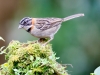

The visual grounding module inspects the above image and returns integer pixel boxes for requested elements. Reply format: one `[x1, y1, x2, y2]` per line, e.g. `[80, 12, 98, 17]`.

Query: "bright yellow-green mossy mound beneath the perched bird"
[0, 41, 68, 75]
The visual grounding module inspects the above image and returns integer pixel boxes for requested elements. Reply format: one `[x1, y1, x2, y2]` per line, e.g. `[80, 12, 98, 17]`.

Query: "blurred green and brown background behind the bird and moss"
[0, 0, 100, 75]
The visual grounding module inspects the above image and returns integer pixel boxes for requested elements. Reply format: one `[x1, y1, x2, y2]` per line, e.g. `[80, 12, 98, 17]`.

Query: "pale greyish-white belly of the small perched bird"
[31, 25, 61, 38]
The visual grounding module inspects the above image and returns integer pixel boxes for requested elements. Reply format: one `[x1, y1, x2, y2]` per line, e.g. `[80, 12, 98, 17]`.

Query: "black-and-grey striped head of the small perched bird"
[18, 17, 32, 30]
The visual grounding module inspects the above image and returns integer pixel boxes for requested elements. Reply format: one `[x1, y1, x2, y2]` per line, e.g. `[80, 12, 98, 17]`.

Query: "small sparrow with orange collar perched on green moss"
[18, 13, 84, 45]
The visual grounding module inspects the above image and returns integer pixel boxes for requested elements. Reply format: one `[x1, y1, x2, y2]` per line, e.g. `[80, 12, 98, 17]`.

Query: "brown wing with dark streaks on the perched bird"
[35, 18, 62, 31]
